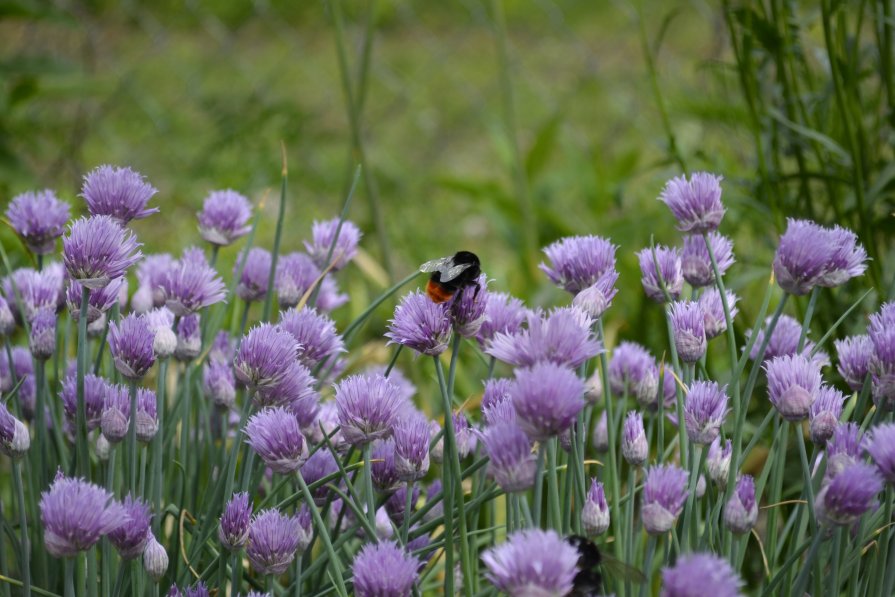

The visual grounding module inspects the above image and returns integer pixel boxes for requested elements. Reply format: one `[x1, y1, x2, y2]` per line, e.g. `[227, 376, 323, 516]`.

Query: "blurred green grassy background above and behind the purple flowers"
[0, 0, 895, 348]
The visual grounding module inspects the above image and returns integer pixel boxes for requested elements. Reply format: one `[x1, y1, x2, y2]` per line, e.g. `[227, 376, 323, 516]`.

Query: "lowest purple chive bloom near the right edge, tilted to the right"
[814, 462, 883, 526]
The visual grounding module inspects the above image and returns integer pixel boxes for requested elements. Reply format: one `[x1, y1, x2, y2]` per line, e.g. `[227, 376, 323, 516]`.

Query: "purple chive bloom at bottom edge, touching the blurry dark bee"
[482, 529, 579, 597]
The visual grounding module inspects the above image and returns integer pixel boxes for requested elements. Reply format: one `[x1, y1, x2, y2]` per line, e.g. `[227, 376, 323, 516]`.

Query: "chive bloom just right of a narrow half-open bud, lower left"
[246, 509, 301, 576]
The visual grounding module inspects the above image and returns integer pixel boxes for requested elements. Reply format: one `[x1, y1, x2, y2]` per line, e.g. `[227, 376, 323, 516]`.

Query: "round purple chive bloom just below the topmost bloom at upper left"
[62, 216, 141, 290]
